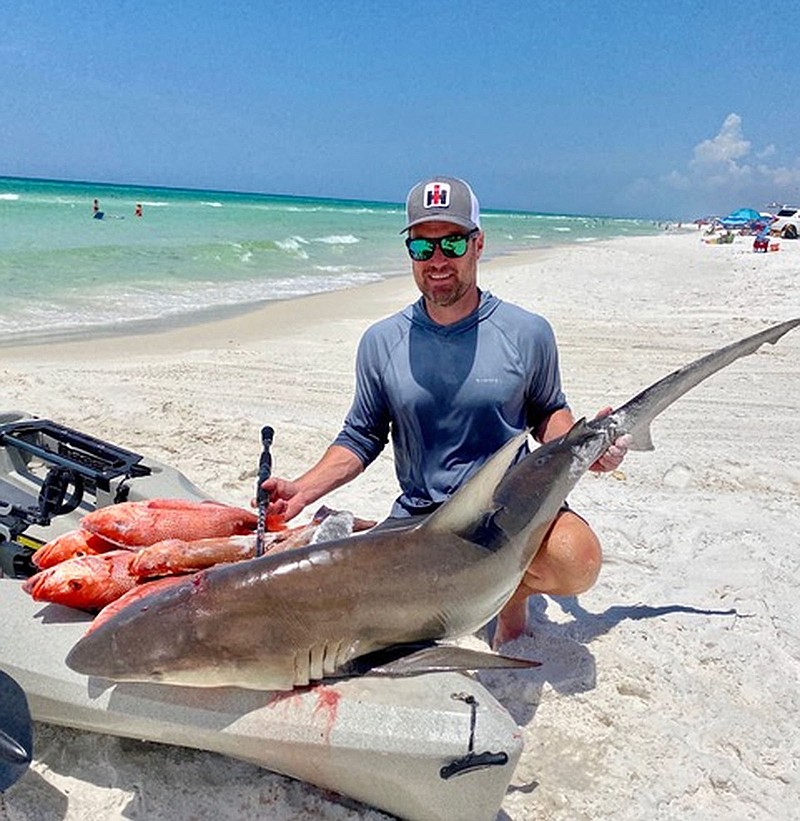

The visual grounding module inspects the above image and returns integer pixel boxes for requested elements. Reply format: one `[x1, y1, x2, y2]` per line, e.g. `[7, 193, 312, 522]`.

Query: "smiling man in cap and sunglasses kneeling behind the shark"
[264, 177, 626, 647]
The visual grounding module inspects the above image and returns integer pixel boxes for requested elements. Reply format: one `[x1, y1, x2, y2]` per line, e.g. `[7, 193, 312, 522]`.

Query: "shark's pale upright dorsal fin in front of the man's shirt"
[420, 430, 529, 532]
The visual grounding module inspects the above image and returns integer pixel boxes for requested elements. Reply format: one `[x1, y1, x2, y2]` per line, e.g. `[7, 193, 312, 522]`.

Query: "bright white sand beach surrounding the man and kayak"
[0, 233, 800, 821]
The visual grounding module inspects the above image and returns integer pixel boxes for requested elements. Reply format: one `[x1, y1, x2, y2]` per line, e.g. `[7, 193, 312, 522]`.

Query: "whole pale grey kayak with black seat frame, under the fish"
[0, 412, 523, 821]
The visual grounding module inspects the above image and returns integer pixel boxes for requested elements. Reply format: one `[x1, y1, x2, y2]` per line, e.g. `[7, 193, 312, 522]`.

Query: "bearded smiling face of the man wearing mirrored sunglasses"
[409, 222, 483, 308]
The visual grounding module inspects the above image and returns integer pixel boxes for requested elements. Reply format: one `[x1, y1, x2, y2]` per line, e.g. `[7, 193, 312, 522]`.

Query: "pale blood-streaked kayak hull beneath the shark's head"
[0, 579, 522, 821]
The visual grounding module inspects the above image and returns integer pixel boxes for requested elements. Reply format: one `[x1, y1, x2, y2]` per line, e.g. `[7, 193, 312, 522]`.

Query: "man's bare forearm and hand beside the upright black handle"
[262, 445, 364, 520]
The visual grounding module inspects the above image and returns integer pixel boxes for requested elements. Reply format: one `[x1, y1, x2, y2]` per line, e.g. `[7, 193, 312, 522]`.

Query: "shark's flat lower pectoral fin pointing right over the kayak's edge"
[328, 642, 541, 677]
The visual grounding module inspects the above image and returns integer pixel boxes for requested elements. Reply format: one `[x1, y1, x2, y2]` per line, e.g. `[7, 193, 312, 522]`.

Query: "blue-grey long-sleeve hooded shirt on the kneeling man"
[334, 292, 567, 516]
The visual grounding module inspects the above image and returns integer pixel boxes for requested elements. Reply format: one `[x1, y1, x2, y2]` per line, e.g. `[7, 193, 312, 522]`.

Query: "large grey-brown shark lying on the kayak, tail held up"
[66, 318, 800, 690]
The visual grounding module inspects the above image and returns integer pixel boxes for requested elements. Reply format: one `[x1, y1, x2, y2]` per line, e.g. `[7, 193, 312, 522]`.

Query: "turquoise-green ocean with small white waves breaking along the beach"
[0, 177, 660, 344]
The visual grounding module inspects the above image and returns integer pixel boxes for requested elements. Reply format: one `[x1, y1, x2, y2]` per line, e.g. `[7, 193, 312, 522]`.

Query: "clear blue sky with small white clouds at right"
[0, 0, 800, 219]
